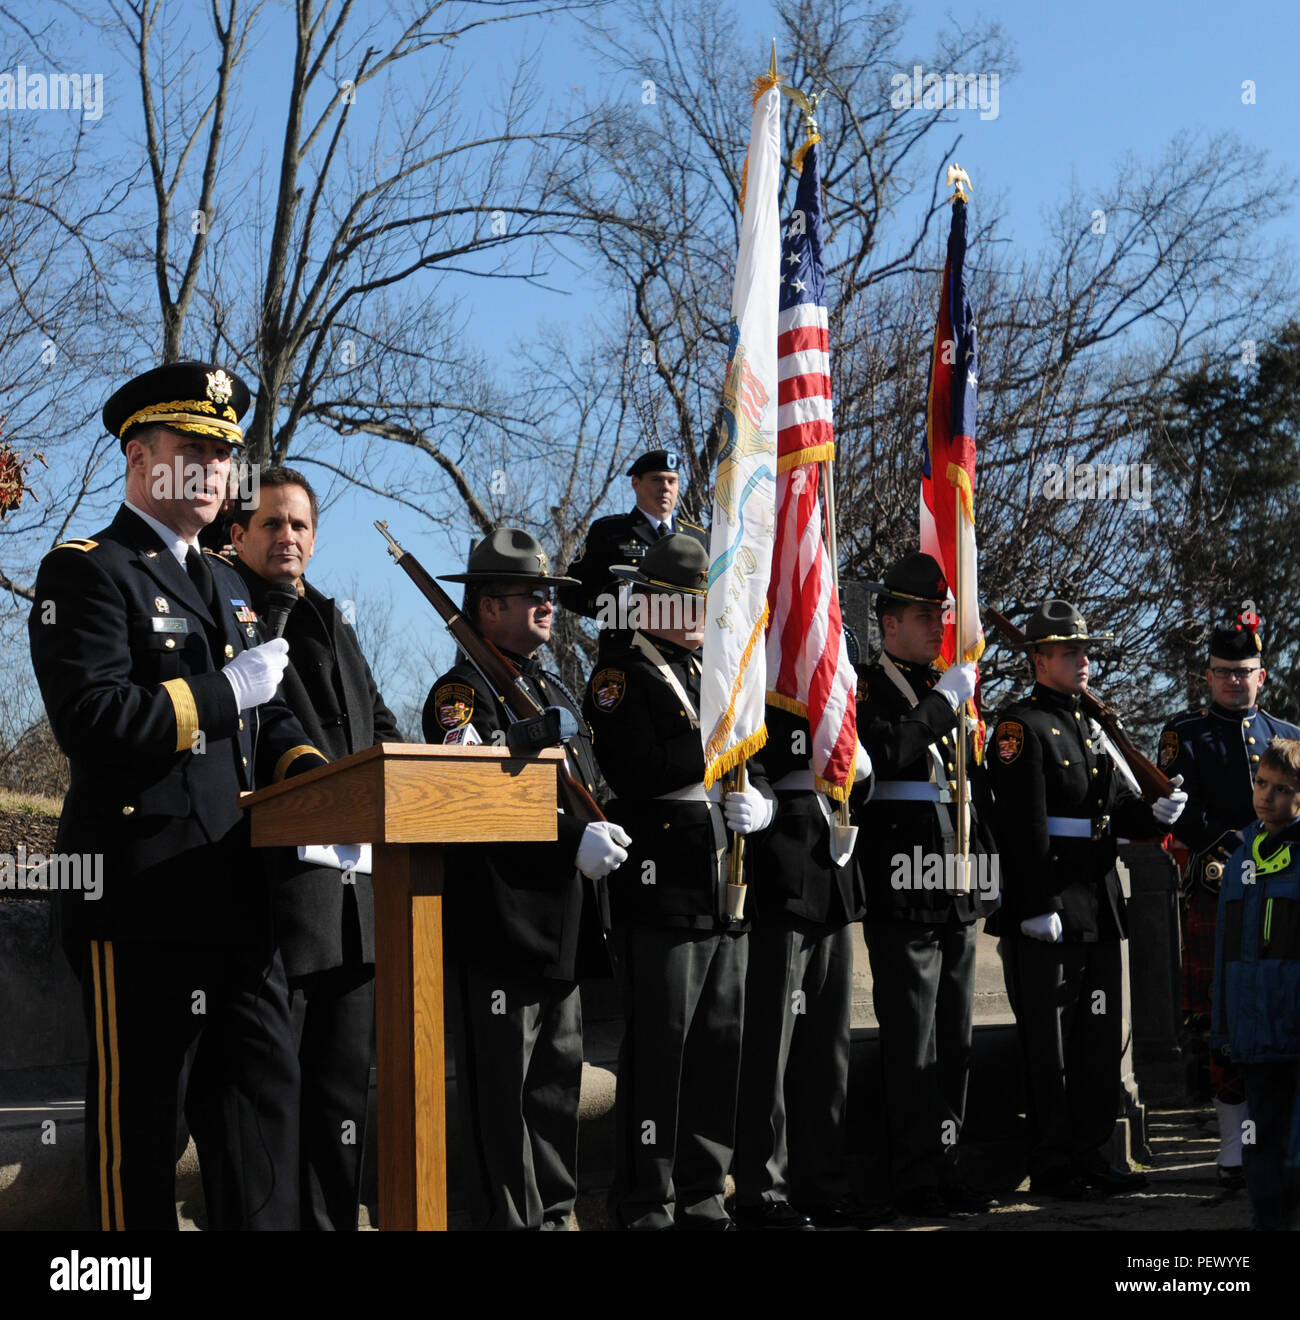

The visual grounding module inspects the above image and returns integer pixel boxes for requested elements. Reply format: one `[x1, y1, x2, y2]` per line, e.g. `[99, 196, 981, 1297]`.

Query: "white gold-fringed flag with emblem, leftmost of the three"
[699, 77, 781, 785]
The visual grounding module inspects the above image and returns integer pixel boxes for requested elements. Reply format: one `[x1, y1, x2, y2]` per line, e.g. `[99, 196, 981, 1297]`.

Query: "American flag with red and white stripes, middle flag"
[767, 141, 858, 801]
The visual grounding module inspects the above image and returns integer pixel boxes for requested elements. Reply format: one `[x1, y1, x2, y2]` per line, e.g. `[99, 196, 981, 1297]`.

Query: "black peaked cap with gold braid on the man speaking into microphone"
[103, 362, 252, 451]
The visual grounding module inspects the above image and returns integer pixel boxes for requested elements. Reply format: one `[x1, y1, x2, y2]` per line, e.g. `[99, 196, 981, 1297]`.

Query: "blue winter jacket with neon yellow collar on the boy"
[1210, 821, 1300, 1064]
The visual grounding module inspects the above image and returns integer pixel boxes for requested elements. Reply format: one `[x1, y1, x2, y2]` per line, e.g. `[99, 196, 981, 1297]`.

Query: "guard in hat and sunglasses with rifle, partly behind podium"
[424, 527, 628, 1230]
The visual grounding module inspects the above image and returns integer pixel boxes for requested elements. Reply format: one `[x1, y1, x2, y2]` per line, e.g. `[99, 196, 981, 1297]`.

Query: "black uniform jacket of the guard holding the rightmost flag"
[853, 657, 998, 925]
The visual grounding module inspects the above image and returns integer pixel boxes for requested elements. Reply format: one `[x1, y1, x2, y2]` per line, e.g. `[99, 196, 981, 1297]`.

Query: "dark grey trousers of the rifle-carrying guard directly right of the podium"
[447, 962, 582, 1229]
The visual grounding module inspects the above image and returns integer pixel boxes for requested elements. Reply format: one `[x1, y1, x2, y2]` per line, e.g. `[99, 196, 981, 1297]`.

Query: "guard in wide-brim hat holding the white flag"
[583, 536, 773, 1229]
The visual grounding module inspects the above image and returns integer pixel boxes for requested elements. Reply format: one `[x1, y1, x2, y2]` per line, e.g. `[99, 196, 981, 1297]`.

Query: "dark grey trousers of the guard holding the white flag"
[611, 924, 750, 1229]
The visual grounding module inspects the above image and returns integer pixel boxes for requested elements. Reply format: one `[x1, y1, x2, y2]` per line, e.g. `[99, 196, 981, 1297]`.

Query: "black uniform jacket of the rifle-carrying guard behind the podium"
[424, 652, 608, 981]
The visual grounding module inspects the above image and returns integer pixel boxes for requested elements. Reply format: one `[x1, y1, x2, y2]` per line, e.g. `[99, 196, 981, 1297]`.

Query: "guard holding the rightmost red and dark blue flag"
[857, 554, 998, 1218]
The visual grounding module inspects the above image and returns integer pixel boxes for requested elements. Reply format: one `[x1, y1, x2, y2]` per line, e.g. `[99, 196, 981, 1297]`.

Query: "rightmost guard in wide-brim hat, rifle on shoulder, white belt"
[990, 601, 1186, 1199]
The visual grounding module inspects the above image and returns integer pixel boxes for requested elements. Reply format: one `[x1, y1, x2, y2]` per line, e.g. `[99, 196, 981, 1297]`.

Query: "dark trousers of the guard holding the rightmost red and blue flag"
[863, 921, 975, 1196]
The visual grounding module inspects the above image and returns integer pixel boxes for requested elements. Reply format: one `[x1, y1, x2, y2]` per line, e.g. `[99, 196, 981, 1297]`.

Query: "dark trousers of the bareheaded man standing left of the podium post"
[289, 962, 375, 1232]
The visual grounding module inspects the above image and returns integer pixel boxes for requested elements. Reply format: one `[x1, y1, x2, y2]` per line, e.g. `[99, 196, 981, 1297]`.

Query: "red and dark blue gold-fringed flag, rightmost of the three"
[921, 194, 985, 668]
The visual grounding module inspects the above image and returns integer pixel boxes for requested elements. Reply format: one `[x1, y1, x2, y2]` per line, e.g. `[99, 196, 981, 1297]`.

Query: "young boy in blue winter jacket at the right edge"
[1210, 738, 1300, 1229]
